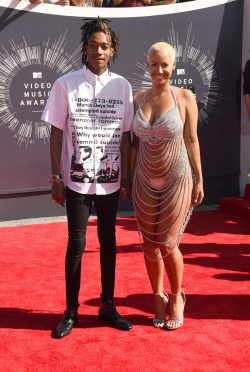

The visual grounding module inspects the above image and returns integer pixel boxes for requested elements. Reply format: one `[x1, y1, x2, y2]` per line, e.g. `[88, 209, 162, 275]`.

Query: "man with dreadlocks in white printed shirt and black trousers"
[42, 17, 134, 338]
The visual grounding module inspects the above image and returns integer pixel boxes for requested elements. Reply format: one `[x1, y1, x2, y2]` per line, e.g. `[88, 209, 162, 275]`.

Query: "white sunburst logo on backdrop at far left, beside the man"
[0, 30, 81, 148]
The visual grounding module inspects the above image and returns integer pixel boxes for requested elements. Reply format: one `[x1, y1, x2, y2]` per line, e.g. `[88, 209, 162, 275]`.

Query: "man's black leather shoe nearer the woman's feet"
[99, 302, 133, 331]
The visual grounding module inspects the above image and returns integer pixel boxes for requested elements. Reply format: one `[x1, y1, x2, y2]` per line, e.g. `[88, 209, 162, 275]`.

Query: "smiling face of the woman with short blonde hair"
[147, 49, 176, 85]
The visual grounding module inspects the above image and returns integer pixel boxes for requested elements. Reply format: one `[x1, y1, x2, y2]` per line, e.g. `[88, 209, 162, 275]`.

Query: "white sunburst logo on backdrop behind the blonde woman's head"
[129, 23, 227, 125]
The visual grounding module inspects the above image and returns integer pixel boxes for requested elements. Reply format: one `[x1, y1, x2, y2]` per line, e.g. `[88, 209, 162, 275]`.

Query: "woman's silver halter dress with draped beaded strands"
[132, 87, 196, 261]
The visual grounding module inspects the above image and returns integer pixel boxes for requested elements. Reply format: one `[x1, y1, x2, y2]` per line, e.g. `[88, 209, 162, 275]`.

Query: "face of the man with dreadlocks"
[86, 32, 114, 70]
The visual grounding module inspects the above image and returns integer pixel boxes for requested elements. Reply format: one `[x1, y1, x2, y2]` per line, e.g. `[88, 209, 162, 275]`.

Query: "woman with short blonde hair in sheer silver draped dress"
[131, 43, 203, 330]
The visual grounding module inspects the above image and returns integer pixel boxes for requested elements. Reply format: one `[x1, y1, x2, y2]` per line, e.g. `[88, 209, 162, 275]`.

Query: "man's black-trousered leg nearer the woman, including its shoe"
[95, 190, 132, 330]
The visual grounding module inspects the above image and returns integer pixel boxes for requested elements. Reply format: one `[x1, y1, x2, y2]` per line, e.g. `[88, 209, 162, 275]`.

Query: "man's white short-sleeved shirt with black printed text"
[42, 66, 134, 195]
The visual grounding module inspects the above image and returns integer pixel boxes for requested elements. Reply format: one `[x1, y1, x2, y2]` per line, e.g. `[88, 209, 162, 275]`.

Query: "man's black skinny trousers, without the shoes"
[65, 187, 120, 308]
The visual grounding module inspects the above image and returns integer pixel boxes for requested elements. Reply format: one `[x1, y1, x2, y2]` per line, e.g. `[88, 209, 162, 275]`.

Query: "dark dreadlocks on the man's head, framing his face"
[81, 16, 120, 73]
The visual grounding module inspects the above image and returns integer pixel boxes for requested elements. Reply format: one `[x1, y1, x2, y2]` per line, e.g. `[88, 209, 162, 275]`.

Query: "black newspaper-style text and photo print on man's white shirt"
[70, 98, 124, 184]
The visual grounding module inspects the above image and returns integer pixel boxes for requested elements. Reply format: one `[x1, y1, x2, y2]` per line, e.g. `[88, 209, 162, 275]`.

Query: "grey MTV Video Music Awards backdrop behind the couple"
[0, 0, 243, 203]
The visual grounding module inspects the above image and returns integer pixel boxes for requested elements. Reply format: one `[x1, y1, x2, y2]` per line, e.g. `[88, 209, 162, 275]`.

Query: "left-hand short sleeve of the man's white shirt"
[41, 80, 68, 130]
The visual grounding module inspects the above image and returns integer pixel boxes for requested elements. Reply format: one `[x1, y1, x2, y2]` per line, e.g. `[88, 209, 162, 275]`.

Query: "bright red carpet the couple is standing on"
[0, 211, 250, 372]
